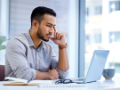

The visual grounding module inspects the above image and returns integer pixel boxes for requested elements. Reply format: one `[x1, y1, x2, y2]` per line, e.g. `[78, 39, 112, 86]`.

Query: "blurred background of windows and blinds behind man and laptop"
[0, 0, 120, 78]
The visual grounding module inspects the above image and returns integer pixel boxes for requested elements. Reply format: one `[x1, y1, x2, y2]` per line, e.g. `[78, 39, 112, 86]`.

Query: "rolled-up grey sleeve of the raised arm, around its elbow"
[51, 50, 69, 79]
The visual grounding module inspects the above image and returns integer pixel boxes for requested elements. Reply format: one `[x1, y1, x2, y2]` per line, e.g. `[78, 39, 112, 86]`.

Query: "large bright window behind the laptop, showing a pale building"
[84, 0, 120, 75]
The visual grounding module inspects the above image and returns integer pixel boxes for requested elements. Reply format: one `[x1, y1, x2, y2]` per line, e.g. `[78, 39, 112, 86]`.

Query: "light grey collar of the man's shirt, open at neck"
[26, 31, 45, 49]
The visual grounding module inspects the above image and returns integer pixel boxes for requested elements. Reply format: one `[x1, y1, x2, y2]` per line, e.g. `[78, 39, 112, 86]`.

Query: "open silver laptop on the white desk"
[72, 50, 109, 84]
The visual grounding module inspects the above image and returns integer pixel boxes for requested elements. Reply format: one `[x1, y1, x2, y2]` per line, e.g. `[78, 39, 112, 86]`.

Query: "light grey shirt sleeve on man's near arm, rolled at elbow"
[5, 40, 36, 80]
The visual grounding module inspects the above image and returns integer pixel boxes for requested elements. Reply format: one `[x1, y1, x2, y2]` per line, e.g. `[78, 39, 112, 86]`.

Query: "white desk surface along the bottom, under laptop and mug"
[0, 74, 120, 90]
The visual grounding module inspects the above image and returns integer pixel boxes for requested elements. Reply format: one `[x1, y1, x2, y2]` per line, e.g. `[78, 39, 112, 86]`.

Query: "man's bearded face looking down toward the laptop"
[37, 14, 56, 41]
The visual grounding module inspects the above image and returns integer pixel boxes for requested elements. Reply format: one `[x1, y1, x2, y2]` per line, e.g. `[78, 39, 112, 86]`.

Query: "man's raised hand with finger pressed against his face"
[50, 28, 67, 48]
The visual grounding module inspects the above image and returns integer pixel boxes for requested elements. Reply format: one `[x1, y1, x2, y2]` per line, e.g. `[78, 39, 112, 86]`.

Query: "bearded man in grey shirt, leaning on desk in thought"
[5, 7, 69, 80]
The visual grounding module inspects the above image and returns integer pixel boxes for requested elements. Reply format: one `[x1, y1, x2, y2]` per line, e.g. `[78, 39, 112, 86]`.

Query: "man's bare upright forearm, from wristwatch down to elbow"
[58, 48, 69, 71]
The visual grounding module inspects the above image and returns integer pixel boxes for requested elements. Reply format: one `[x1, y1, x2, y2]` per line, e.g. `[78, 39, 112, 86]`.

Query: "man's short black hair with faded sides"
[31, 6, 56, 27]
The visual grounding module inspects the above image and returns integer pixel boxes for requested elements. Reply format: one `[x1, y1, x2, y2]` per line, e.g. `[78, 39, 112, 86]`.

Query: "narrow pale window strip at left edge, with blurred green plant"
[0, 0, 9, 65]
